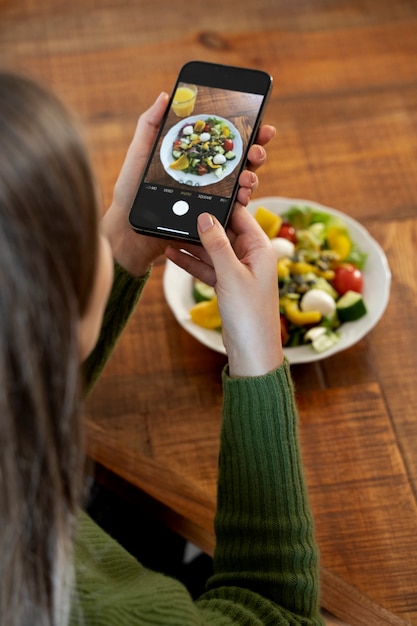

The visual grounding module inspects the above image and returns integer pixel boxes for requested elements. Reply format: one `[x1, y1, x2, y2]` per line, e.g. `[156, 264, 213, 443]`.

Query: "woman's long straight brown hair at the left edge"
[0, 72, 98, 626]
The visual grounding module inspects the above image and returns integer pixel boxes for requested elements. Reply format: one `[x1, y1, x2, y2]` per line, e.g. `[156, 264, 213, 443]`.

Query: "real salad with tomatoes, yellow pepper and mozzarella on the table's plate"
[190, 205, 367, 352]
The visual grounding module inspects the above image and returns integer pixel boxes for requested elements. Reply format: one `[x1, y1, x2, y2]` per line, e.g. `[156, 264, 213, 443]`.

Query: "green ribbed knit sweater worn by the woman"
[70, 268, 323, 626]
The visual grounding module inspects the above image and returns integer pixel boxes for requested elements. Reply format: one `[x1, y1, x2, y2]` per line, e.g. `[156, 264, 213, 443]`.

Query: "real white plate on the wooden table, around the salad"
[164, 197, 391, 364]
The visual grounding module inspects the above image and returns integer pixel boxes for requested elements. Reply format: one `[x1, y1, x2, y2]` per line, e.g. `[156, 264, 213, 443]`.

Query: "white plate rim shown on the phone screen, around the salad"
[160, 113, 243, 187]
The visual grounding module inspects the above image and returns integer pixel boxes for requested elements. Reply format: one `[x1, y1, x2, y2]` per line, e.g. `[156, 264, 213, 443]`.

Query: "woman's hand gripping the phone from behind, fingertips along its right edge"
[102, 92, 275, 276]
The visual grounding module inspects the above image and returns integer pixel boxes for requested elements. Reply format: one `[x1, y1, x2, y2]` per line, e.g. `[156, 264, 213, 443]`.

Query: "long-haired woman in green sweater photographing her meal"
[0, 74, 321, 626]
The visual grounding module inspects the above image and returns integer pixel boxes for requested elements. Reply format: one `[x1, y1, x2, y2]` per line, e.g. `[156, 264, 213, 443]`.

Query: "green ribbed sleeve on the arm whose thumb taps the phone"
[196, 363, 322, 624]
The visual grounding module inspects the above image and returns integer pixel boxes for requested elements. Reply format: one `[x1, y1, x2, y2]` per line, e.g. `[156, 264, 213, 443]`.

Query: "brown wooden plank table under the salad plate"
[0, 0, 417, 626]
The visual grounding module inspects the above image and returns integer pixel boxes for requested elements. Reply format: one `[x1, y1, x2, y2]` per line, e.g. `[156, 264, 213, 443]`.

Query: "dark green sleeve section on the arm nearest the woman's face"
[82, 263, 150, 392]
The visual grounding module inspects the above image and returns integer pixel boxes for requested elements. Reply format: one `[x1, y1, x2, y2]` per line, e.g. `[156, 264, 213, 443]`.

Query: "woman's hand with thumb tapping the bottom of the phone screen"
[166, 204, 284, 377]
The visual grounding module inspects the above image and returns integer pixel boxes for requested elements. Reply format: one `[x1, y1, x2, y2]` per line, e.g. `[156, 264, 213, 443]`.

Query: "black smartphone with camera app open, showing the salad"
[129, 61, 272, 242]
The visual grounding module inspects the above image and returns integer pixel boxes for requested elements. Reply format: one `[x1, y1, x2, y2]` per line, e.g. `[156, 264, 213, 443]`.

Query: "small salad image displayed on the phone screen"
[169, 117, 236, 178]
